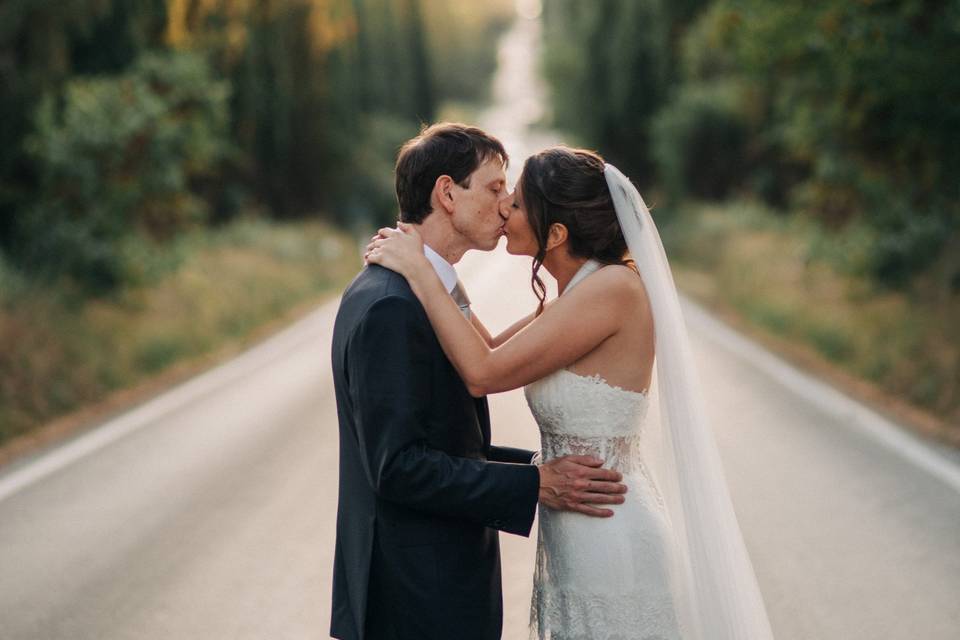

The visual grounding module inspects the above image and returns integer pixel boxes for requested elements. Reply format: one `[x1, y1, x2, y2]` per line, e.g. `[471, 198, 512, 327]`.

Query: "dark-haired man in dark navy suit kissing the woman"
[330, 123, 622, 640]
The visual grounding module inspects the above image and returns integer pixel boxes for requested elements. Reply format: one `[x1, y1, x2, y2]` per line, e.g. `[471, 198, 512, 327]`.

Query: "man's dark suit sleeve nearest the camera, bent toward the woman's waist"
[347, 296, 540, 535]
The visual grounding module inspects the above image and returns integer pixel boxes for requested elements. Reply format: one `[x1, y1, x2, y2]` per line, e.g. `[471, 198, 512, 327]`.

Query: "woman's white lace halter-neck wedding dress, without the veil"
[524, 261, 683, 640]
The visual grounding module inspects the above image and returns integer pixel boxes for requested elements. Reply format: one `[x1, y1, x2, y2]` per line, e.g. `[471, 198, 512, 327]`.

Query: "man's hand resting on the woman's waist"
[538, 456, 627, 518]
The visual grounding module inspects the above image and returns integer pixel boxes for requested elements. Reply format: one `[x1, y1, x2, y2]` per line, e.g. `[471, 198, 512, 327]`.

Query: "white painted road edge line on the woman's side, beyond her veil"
[683, 298, 960, 493]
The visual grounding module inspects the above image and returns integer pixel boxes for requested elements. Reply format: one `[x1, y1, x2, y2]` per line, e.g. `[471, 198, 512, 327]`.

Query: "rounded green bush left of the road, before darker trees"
[14, 53, 230, 292]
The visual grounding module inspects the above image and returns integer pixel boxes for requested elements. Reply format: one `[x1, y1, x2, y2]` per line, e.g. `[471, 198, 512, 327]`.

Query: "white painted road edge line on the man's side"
[0, 299, 339, 502]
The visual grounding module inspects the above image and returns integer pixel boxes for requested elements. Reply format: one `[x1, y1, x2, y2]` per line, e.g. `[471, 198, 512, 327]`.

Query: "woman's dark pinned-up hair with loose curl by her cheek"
[519, 146, 633, 313]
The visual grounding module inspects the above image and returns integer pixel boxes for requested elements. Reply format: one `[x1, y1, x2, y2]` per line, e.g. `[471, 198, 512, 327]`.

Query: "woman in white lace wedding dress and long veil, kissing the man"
[367, 147, 772, 640]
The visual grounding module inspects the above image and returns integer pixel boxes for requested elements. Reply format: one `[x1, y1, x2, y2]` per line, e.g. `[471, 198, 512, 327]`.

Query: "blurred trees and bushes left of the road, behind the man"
[0, 0, 513, 293]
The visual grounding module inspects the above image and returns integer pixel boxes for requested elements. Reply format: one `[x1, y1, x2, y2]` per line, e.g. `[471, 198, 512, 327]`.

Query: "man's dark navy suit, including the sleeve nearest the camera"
[330, 266, 539, 640]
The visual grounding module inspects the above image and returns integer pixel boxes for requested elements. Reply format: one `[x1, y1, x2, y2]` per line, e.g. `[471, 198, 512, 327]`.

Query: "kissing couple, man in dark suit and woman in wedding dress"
[331, 123, 772, 640]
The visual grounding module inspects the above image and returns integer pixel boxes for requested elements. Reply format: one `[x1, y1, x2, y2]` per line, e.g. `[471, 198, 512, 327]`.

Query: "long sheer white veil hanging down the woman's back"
[604, 164, 773, 640]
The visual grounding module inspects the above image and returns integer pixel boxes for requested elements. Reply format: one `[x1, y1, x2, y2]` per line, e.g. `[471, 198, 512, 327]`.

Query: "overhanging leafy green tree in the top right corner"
[716, 0, 960, 285]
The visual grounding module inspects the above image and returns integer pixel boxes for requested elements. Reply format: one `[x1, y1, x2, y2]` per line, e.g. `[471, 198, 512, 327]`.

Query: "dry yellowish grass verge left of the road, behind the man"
[0, 220, 359, 442]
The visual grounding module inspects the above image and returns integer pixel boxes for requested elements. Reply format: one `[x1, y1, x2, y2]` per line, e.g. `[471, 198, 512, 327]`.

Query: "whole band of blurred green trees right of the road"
[544, 0, 960, 292]
